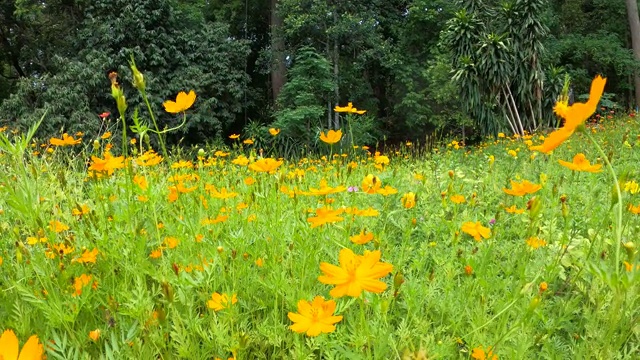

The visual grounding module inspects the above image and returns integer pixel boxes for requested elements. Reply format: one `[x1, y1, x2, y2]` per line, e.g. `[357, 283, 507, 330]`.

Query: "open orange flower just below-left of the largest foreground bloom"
[287, 296, 342, 336]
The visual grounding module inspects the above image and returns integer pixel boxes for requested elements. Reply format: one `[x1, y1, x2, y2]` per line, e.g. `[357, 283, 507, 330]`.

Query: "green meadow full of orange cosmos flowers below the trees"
[0, 79, 640, 359]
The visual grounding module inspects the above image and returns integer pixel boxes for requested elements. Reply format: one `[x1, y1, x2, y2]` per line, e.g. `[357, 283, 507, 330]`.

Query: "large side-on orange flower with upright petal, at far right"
[529, 75, 607, 154]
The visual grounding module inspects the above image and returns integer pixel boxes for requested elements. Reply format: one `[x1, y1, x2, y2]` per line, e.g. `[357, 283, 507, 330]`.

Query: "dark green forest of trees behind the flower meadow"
[0, 0, 640, 149]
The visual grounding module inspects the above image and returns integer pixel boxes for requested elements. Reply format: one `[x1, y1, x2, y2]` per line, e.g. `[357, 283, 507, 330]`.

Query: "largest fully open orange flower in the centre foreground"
[318, 249, 393, 298]
